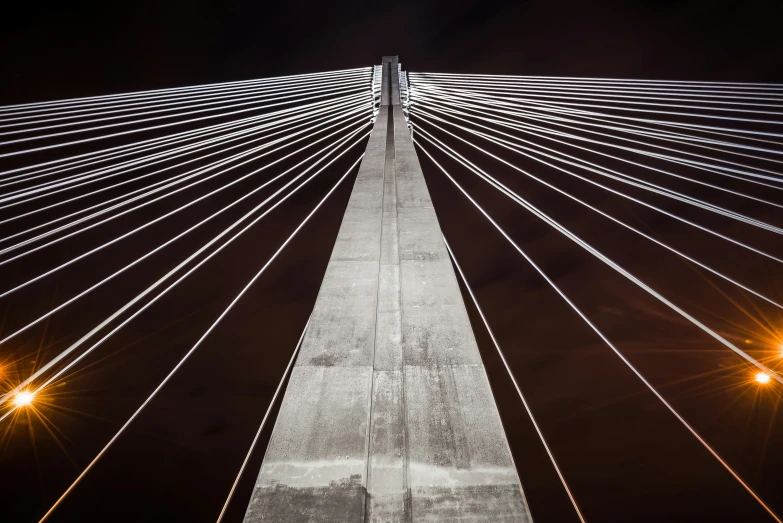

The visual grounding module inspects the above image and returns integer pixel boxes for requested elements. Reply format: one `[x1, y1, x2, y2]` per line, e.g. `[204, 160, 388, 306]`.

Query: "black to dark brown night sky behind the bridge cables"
[0, 1, 783, 523]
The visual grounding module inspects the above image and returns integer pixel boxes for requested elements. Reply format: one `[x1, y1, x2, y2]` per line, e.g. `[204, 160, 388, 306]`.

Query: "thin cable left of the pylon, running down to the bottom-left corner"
[30, 154, 364, 523]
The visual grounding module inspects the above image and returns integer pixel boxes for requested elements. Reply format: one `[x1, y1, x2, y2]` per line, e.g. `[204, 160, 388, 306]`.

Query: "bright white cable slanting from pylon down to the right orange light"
[416, 131, 783, 384]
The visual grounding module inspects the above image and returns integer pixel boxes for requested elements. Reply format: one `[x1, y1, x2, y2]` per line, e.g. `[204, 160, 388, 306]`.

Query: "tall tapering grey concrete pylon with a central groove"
[245, 62, 530, 523]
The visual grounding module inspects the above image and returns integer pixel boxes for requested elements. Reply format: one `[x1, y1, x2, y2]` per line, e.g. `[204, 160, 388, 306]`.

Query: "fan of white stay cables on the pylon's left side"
[0, 67, 381, 521]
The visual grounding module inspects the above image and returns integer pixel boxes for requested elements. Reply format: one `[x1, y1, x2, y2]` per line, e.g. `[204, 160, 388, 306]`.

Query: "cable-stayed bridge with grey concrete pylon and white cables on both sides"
[0, 57, 783, 522]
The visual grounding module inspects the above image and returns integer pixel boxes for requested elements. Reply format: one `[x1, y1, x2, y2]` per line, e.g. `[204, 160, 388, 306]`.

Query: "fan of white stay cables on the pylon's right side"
[401, 73, 783, 522]
